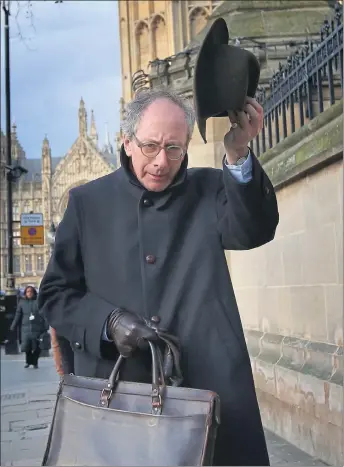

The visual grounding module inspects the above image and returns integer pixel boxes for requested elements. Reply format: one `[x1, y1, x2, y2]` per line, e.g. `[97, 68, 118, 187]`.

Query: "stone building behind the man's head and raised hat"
[118, 0, 330, 167]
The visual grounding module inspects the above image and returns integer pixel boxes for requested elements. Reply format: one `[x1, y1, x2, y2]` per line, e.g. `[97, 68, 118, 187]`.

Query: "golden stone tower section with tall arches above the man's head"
[118, 0, 222, 105]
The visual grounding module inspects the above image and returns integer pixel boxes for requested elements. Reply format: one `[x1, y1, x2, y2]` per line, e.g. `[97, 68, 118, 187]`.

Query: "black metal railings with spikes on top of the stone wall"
[254, 4, 343, 157]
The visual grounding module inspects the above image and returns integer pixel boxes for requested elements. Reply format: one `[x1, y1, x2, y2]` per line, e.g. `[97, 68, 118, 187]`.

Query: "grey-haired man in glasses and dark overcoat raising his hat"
[39, 90, 278, 465]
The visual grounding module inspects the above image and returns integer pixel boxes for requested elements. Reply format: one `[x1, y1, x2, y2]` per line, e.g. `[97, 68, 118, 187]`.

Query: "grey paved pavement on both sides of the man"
[1, 349, 327, 466]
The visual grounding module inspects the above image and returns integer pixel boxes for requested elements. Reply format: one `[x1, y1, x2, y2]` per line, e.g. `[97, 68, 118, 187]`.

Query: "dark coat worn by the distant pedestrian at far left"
[11, 298, 49, 352]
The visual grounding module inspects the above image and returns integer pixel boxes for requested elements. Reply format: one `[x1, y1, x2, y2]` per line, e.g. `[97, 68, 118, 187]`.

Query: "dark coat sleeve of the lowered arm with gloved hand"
[38, 190, 116, 358]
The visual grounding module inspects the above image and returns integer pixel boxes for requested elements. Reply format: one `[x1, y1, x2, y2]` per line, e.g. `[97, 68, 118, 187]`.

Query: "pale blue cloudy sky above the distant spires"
[1, 0, 122, 158]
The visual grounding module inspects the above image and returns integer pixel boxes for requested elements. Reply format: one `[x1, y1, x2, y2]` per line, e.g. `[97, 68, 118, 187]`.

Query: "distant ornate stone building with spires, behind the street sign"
[0, 99, 118, 290]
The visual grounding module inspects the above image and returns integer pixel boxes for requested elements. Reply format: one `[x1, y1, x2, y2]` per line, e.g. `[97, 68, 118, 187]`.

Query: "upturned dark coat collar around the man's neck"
[120, 144, 188, 207]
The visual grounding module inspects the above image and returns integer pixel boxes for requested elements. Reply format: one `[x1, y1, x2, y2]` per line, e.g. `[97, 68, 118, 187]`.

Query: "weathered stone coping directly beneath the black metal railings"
[259, 100, 343, 189]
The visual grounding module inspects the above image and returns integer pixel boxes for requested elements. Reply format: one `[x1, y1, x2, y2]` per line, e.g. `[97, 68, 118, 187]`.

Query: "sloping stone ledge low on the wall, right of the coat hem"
[245, 330, 344, 386]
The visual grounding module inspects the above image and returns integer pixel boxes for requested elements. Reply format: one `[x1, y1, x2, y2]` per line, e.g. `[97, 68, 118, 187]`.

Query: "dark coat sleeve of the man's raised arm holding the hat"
[216, 151, 279, 250]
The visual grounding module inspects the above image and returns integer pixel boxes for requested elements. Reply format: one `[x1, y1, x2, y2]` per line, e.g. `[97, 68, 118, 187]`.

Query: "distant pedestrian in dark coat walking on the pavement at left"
[10, 286, 49, 368]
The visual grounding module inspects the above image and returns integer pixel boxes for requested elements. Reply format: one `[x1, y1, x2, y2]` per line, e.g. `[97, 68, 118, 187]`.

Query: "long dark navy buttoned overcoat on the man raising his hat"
[39, 147, 279, 465]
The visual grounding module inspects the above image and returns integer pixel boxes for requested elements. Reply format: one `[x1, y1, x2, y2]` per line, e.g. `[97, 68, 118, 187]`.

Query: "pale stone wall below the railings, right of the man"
[228, 101, 344, 465]
